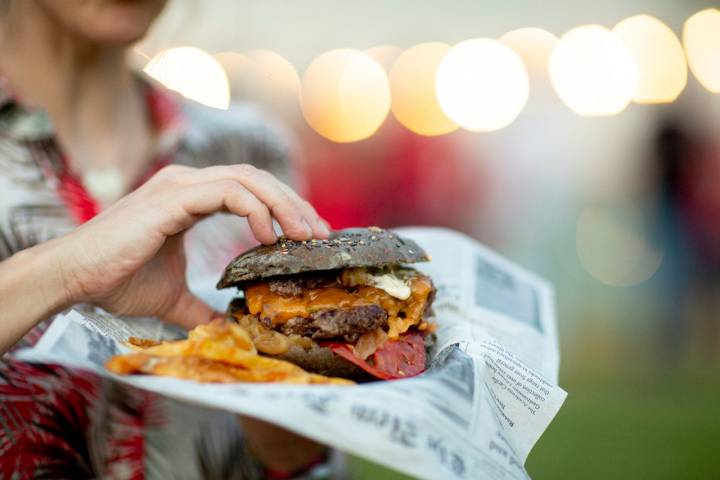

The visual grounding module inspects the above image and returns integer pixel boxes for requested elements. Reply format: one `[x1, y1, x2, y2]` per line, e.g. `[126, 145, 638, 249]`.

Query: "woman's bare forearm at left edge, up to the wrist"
[0, 240, 70, 353]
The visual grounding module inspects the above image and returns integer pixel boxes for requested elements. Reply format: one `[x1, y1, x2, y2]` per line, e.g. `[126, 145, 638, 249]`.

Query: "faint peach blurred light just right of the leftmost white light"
[214, 50, 300, 112]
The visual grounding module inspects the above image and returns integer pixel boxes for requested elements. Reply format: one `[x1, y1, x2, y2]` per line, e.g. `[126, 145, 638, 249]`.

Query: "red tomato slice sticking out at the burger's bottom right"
[321, 332, 425, 380]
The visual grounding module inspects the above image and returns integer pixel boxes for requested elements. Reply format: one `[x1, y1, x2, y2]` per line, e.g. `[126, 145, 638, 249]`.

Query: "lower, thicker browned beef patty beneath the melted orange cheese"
[275, 305, 387, 343]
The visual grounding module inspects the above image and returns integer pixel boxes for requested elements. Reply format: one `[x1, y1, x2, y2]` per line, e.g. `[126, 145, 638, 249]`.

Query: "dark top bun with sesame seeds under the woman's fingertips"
[217, 227, 430, 288]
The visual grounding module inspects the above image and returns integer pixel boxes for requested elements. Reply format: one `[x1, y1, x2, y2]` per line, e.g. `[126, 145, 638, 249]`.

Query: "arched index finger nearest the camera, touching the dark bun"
[162, 180, 277, 244]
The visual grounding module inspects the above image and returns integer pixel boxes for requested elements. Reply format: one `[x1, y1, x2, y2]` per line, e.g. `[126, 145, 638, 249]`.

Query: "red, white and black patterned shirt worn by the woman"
[0, 78, 324, 479]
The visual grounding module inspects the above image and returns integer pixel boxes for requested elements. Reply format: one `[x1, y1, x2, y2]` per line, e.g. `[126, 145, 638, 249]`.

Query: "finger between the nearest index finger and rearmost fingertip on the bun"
[174, 164, 314, 240]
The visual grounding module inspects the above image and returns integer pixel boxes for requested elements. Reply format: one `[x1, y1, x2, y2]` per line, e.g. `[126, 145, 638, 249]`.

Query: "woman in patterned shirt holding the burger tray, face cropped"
[0, 0, 328, 478]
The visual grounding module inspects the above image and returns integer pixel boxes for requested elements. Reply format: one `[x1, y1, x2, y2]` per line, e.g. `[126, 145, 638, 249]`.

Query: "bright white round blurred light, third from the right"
[550, 25, 638, 116]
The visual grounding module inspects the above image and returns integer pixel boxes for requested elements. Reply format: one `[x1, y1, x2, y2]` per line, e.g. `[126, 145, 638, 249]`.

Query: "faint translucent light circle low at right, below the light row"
[576, 205, 663, 287]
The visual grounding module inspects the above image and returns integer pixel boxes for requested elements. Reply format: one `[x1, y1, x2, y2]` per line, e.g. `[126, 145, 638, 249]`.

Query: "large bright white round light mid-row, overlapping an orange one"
[435, 39, 528, 132]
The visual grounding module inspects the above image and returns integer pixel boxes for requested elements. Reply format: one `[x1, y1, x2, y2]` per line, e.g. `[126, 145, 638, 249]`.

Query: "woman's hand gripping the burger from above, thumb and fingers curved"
[59, 165, 329, 328]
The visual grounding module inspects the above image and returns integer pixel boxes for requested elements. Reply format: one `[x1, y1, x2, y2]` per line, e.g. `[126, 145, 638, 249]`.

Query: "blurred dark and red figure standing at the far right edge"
[653, 118, 720, 362]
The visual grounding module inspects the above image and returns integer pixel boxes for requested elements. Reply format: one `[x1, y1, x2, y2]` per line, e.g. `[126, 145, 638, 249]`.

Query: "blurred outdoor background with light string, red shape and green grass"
[133, 0, 720, 479]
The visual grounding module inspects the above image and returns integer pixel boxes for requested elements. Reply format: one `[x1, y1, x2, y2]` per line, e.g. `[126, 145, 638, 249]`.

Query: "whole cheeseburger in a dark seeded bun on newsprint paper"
[218, 227, 435, 381]
